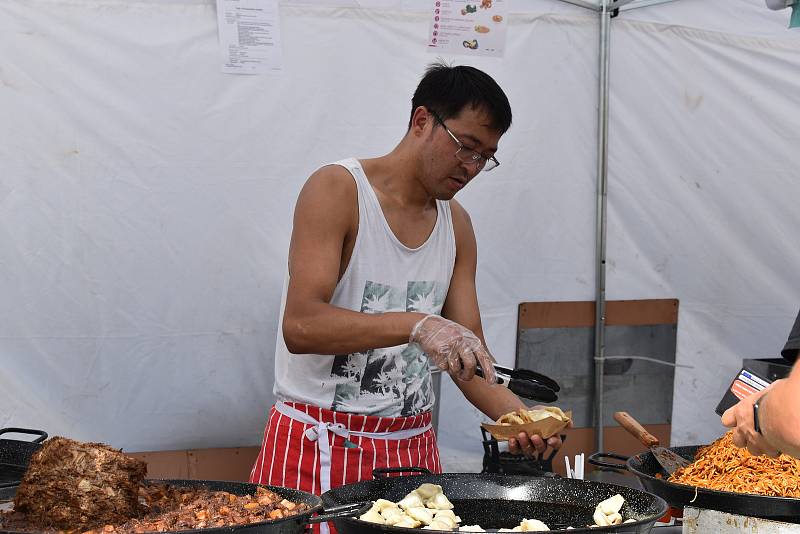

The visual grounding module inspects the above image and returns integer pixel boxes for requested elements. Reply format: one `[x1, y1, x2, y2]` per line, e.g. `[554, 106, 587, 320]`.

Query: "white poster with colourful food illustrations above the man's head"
[428, 0, 508, 57]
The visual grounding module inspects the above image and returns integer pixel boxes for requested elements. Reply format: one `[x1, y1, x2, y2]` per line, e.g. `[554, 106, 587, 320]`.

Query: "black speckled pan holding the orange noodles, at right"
[589, 445, 800, 523]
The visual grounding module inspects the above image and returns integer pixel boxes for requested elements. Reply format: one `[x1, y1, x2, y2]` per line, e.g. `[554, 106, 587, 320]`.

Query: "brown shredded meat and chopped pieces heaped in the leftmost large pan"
[0, 437, 309, 534]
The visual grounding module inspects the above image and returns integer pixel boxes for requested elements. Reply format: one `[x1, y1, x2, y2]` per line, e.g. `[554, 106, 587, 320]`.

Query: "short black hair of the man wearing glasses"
[408, 62, 511, 134]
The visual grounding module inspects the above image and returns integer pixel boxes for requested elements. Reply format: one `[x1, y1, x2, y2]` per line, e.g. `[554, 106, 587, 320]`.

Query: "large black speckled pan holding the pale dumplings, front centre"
[322, 468, 668, 534]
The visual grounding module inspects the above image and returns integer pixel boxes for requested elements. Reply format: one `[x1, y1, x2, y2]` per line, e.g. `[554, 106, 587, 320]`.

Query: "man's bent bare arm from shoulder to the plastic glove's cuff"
[283, 165, 425, 354]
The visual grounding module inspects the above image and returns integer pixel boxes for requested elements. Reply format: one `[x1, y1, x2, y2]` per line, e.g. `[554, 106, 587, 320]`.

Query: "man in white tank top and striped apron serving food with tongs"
[250, 64, 561, 506]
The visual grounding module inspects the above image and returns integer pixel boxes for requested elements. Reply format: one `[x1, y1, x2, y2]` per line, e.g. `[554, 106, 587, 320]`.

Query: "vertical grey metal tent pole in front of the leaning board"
[594, 0, 611, 451]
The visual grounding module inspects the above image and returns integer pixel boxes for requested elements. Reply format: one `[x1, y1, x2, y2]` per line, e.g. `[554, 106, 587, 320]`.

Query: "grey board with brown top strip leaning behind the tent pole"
[515, 299, 679, 427]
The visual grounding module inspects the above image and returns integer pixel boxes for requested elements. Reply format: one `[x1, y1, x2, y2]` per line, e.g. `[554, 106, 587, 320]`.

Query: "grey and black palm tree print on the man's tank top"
[331, 280, 447, 416]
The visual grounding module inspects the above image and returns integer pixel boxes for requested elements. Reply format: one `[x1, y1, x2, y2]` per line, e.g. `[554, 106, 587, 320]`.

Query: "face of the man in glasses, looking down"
[421, 107, 502, 200]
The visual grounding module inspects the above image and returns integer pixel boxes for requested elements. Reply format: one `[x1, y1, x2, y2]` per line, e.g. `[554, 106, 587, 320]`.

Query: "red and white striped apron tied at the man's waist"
[250, 402, 442, 534]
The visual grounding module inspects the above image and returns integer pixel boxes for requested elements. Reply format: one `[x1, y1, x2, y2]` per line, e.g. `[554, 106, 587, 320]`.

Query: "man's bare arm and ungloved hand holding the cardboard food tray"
[442, 200, 561, 454]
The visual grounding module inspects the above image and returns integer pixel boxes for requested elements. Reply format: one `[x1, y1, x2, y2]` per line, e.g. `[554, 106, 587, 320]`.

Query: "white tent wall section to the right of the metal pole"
[608, 15, 800, 443]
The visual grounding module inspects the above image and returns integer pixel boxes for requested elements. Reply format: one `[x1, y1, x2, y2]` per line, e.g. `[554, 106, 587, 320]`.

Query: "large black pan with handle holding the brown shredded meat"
[0, 480, 371, 534]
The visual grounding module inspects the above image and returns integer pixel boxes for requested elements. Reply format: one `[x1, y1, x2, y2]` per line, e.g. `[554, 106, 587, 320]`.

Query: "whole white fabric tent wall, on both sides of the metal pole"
[0, 0, 800, 470]
